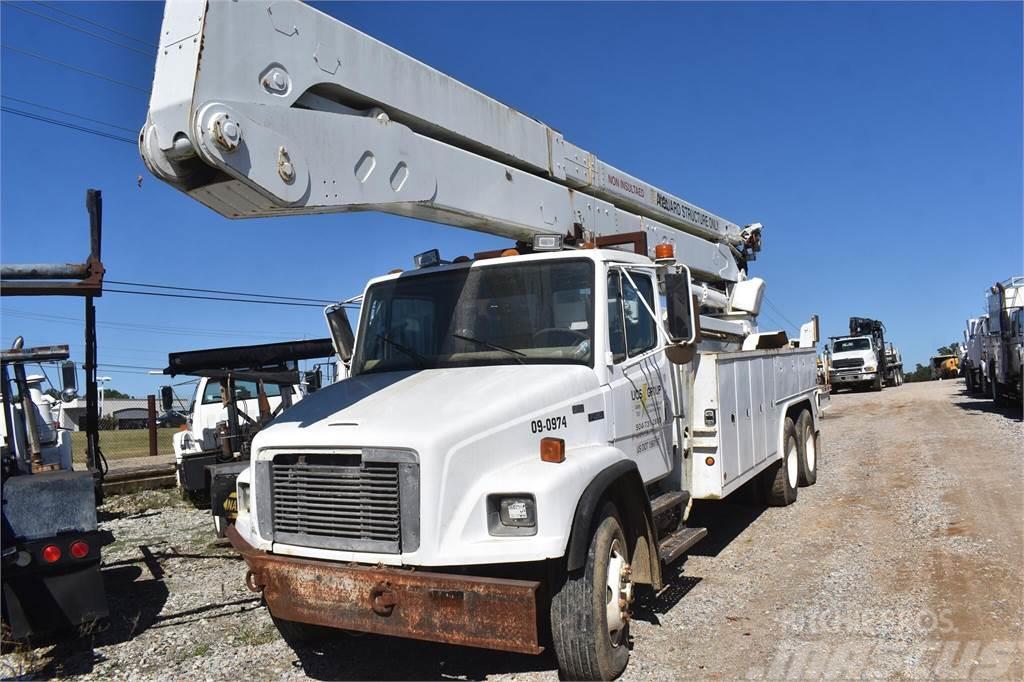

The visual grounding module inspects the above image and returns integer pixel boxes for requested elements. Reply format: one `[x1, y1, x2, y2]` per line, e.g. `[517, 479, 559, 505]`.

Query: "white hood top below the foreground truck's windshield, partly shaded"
[253, 365, 599, 452]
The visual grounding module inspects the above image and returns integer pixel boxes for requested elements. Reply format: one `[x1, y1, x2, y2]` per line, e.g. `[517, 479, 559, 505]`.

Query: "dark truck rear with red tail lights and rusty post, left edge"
[0, 189, 112, 643]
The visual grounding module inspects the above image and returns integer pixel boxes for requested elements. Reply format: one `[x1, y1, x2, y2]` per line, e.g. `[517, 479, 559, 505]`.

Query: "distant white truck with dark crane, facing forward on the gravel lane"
[829, 317, 903, 391]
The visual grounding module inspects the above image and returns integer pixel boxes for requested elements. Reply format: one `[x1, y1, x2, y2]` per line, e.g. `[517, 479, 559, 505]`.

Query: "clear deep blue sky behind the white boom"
[0, 2, 1024, 394]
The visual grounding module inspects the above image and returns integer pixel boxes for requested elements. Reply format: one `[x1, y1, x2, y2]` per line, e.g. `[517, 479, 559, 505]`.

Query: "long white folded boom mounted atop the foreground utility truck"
[139, 0, 760, 286]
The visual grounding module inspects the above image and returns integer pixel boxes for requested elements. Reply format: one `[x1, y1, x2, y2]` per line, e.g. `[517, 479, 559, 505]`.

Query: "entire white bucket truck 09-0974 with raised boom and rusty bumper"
[139, 1, 819, 679]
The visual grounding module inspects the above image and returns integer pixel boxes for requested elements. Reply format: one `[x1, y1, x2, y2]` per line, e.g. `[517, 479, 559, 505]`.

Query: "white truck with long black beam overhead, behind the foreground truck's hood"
[161, 338, 335, 537]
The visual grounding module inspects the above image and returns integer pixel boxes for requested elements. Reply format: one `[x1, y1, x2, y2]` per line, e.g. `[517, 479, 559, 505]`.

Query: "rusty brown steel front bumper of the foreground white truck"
[227, 525, 544, 653]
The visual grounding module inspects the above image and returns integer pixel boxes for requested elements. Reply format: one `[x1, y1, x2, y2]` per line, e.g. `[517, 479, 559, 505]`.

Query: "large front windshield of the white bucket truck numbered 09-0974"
[352, 259, 594, 374]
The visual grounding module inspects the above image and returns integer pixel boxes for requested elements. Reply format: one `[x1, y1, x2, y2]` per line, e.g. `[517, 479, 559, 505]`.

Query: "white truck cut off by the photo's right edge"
[983, 276, 1024, 403]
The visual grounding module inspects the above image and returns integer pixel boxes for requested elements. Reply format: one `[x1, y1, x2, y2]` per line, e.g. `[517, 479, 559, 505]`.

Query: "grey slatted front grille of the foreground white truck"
[270, 454, 401, 553]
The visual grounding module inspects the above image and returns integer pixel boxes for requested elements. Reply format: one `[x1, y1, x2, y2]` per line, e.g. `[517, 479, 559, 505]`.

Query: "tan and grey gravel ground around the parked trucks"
[0, 381, 1024, 680]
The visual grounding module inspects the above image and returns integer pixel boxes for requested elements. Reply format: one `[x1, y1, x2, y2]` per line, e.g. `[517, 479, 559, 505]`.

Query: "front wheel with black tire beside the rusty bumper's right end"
[551, 502, 633, 680]
